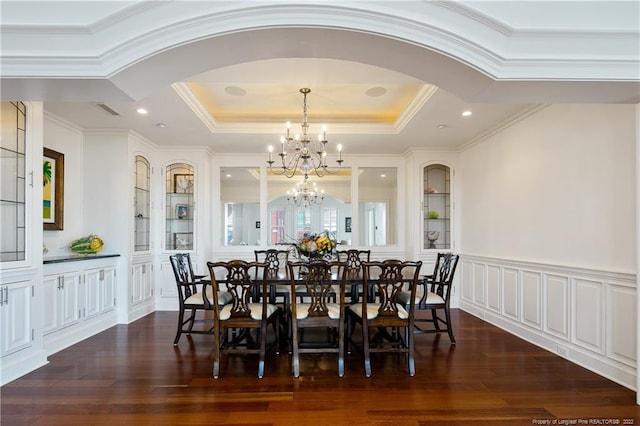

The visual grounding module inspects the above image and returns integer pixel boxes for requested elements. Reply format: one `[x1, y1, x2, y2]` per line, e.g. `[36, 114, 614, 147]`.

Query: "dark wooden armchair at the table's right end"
[401, 253, 460, 345]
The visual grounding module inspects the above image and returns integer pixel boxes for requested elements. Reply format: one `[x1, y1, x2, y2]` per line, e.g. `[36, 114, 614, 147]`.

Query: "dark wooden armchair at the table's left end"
[169, 253, 231, 346]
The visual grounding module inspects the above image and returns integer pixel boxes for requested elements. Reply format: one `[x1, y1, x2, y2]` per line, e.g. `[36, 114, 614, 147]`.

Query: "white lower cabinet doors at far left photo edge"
[0, 281, 33, 356]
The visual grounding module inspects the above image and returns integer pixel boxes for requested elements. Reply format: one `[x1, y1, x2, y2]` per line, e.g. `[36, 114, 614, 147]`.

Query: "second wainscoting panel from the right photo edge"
[572, 278, 604, 353]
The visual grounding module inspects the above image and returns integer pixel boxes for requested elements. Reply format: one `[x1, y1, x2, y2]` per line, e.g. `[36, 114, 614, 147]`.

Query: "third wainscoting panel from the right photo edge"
[544, 274, 569, 340]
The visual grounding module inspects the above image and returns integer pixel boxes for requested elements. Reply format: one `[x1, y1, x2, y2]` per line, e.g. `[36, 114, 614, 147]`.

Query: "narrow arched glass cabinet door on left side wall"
[133, 155, 151, 251]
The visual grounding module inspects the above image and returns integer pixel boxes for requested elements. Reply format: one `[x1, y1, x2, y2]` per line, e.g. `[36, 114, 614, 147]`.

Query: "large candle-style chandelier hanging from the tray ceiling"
[267, 88, 343, 180]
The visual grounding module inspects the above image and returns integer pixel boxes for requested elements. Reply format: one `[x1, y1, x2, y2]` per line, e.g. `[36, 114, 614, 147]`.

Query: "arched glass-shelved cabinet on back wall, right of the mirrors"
[422, 164, 451, 250]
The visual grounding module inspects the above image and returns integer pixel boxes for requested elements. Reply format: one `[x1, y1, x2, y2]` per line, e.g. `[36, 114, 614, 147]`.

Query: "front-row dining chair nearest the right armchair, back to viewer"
[346, 259, 422, 377]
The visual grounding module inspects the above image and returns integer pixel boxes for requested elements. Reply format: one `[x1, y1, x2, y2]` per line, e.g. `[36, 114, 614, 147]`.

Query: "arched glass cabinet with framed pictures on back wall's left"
[165, 163, 195, 251]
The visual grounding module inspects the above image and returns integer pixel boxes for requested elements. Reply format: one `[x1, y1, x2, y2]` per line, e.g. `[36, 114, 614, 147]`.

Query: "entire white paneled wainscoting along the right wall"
[454, 254, 638, 390]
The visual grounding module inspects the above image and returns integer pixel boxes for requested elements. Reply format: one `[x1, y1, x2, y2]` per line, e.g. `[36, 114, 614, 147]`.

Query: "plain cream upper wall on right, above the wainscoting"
[460, 105, 637, 273]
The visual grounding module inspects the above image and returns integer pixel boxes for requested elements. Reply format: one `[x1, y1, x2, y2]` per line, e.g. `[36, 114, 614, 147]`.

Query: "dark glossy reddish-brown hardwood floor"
[0, 310, 640, 426]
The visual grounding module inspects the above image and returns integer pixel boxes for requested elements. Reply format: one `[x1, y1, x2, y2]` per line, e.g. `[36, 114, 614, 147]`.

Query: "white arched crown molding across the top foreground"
[0, 1, 640, 81]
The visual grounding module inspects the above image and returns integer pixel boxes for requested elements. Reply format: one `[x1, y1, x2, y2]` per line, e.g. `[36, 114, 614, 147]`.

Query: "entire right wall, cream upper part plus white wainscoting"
[459, 105, 638, 389]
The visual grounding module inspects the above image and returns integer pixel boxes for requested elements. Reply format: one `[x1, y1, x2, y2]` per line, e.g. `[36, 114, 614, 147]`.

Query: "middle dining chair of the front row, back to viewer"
[287, 260, 346, 377]
